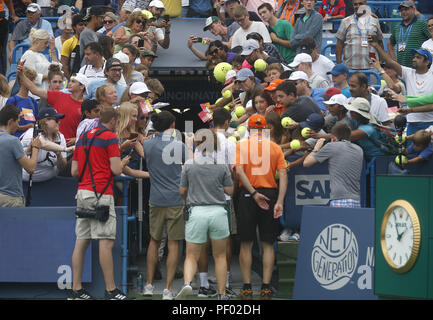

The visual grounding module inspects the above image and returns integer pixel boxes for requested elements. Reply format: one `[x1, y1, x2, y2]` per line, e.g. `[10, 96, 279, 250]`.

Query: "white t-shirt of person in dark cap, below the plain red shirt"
[21, 128, 67, 182]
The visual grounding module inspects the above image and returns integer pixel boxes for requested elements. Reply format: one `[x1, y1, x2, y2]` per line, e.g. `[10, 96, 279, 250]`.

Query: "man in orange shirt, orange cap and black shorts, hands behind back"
[234, 114, 287, 300]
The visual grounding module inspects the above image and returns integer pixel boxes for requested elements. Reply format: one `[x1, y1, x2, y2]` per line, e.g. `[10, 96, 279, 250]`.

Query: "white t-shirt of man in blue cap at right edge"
[401, 66, 433, 122]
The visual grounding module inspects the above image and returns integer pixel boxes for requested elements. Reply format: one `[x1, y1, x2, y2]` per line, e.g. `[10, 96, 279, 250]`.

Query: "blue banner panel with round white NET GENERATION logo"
[294, 206, 376, 299]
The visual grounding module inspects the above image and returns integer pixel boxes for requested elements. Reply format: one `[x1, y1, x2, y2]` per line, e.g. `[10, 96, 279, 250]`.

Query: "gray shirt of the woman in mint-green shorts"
[180, 153, 233, 206]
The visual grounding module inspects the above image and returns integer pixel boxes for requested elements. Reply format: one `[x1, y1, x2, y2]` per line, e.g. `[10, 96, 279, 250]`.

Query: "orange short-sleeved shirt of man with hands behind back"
[234, 134, 287, 188]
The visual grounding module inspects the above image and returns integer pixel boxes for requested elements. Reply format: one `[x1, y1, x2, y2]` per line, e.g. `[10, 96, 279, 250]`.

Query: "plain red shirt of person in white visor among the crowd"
[47, 90, 82, 139]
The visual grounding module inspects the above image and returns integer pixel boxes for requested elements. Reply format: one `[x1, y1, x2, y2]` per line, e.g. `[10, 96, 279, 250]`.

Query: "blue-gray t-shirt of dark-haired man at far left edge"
[0, 131, 25, 197]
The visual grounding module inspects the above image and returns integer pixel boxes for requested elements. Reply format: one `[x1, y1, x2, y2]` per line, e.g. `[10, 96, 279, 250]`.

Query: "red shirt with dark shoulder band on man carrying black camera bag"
[72, 127, 120, 195]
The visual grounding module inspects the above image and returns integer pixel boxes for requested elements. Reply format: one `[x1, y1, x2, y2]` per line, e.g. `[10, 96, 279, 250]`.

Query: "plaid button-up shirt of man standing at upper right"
[335, 15, 383, 70]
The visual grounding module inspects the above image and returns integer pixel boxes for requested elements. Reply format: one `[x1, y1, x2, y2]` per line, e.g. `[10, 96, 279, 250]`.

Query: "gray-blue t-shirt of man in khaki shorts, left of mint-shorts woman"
[143, 134, 187, 207]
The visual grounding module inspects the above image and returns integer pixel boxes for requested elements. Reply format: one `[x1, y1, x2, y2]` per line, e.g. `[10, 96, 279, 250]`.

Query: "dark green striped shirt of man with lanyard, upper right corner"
[389, 17, 431, 68]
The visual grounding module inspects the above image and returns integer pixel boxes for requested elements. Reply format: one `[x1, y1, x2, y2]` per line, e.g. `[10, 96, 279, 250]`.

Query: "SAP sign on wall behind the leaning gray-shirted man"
[295, 174, 331, 206]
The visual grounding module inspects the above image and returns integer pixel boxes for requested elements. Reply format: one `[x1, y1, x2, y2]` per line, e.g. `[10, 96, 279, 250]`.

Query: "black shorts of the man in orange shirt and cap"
[237, 188, 279, 243]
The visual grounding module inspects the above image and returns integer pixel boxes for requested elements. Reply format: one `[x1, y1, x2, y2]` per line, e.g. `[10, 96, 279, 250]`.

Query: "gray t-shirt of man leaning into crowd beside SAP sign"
[313, 140, 364, 201]
